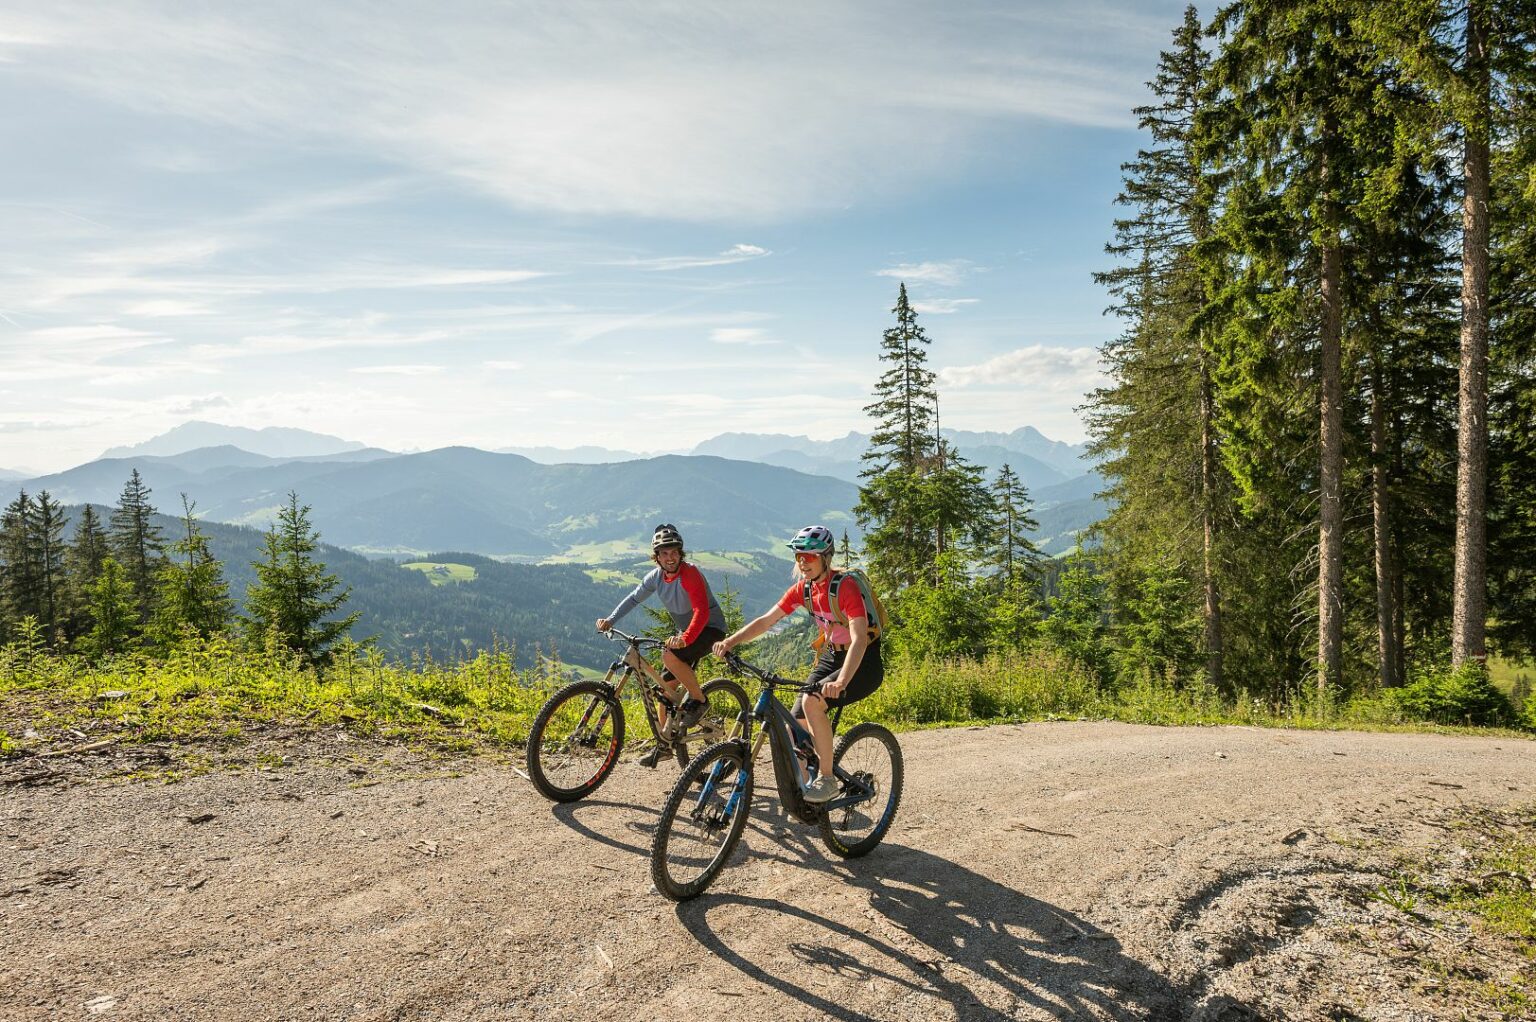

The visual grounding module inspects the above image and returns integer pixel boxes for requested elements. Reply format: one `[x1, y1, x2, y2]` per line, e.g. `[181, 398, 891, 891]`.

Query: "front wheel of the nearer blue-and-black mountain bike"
[651, 741, 753, 901]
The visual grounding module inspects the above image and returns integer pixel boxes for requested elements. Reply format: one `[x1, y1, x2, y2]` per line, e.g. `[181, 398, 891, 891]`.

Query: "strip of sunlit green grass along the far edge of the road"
[0, 639, 1522, 756]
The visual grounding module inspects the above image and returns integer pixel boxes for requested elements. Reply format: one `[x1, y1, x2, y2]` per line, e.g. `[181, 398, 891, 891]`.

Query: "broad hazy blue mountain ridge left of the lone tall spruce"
[26, 447, 859, 561]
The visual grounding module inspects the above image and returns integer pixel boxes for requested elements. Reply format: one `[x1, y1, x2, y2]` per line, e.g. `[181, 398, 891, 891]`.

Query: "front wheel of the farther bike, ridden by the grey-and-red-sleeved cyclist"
[527, 681, 624, 802]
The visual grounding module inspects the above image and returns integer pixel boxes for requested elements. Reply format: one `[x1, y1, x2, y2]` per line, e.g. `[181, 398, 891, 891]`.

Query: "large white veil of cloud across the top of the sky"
[0, 0, 1167, 218]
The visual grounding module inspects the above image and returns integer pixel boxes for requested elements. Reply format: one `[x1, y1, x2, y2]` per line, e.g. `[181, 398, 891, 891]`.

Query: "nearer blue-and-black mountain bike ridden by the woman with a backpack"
[651, 653, 903, 901]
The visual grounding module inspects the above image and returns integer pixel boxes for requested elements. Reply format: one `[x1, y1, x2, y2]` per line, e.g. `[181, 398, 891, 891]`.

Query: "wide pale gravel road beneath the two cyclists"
[0, 722, 1536, 1022]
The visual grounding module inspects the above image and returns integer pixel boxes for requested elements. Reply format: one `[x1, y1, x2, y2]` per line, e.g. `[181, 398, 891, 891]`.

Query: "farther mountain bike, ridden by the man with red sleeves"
[525, 629, 748, 802]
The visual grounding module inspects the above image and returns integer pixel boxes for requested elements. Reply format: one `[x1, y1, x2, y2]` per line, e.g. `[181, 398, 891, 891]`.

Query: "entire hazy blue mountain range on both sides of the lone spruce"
[18, 423, 1103, 553]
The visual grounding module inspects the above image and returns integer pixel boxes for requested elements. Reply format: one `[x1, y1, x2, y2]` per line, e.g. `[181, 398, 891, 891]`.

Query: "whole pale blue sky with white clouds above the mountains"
[0, 0, 1183, 472]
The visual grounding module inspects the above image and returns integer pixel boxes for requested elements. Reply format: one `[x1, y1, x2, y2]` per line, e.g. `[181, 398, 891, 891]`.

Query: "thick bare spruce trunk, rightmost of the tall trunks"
[1450, 0, 1490, 665]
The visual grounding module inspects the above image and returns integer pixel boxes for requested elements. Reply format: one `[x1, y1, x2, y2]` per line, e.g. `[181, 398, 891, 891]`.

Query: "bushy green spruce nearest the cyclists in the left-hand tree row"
[244, 492, 358, 662]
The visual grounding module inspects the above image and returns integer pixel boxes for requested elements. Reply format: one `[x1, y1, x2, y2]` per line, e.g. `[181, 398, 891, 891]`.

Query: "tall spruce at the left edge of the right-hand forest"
[1089, 6, 1232, 685]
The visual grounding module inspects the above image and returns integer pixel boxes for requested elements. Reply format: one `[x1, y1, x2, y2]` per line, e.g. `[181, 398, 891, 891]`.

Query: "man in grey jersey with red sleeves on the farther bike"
[598, 526, 725, 767]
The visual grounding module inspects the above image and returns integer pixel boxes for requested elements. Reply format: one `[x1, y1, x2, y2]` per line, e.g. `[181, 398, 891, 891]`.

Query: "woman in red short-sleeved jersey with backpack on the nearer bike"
[714, 526, 885, 802]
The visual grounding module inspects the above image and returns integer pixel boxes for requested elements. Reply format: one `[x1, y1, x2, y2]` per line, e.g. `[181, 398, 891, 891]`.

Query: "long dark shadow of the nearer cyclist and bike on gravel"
[677, 844, 1183, 1022]
